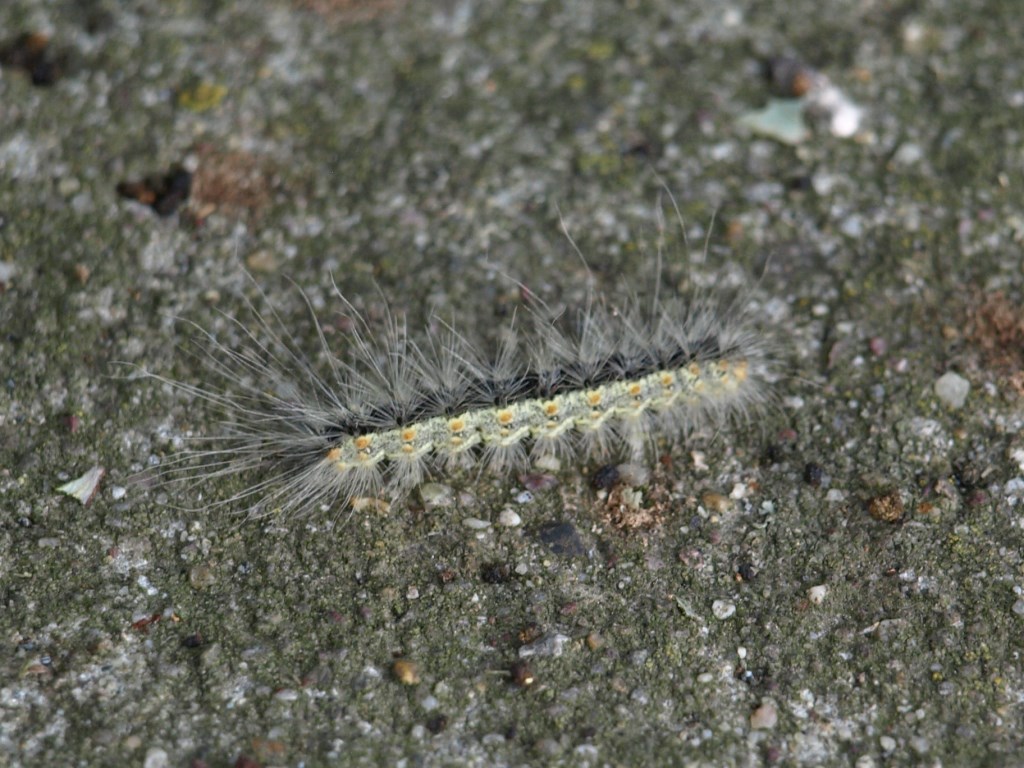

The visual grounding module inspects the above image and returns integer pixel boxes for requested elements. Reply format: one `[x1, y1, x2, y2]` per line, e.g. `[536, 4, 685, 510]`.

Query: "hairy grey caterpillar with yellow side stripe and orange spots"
[158, 262, 770, 514]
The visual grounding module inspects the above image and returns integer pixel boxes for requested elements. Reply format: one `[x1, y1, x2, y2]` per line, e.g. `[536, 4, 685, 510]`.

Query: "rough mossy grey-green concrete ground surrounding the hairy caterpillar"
[0, 0, 1024, 768]
